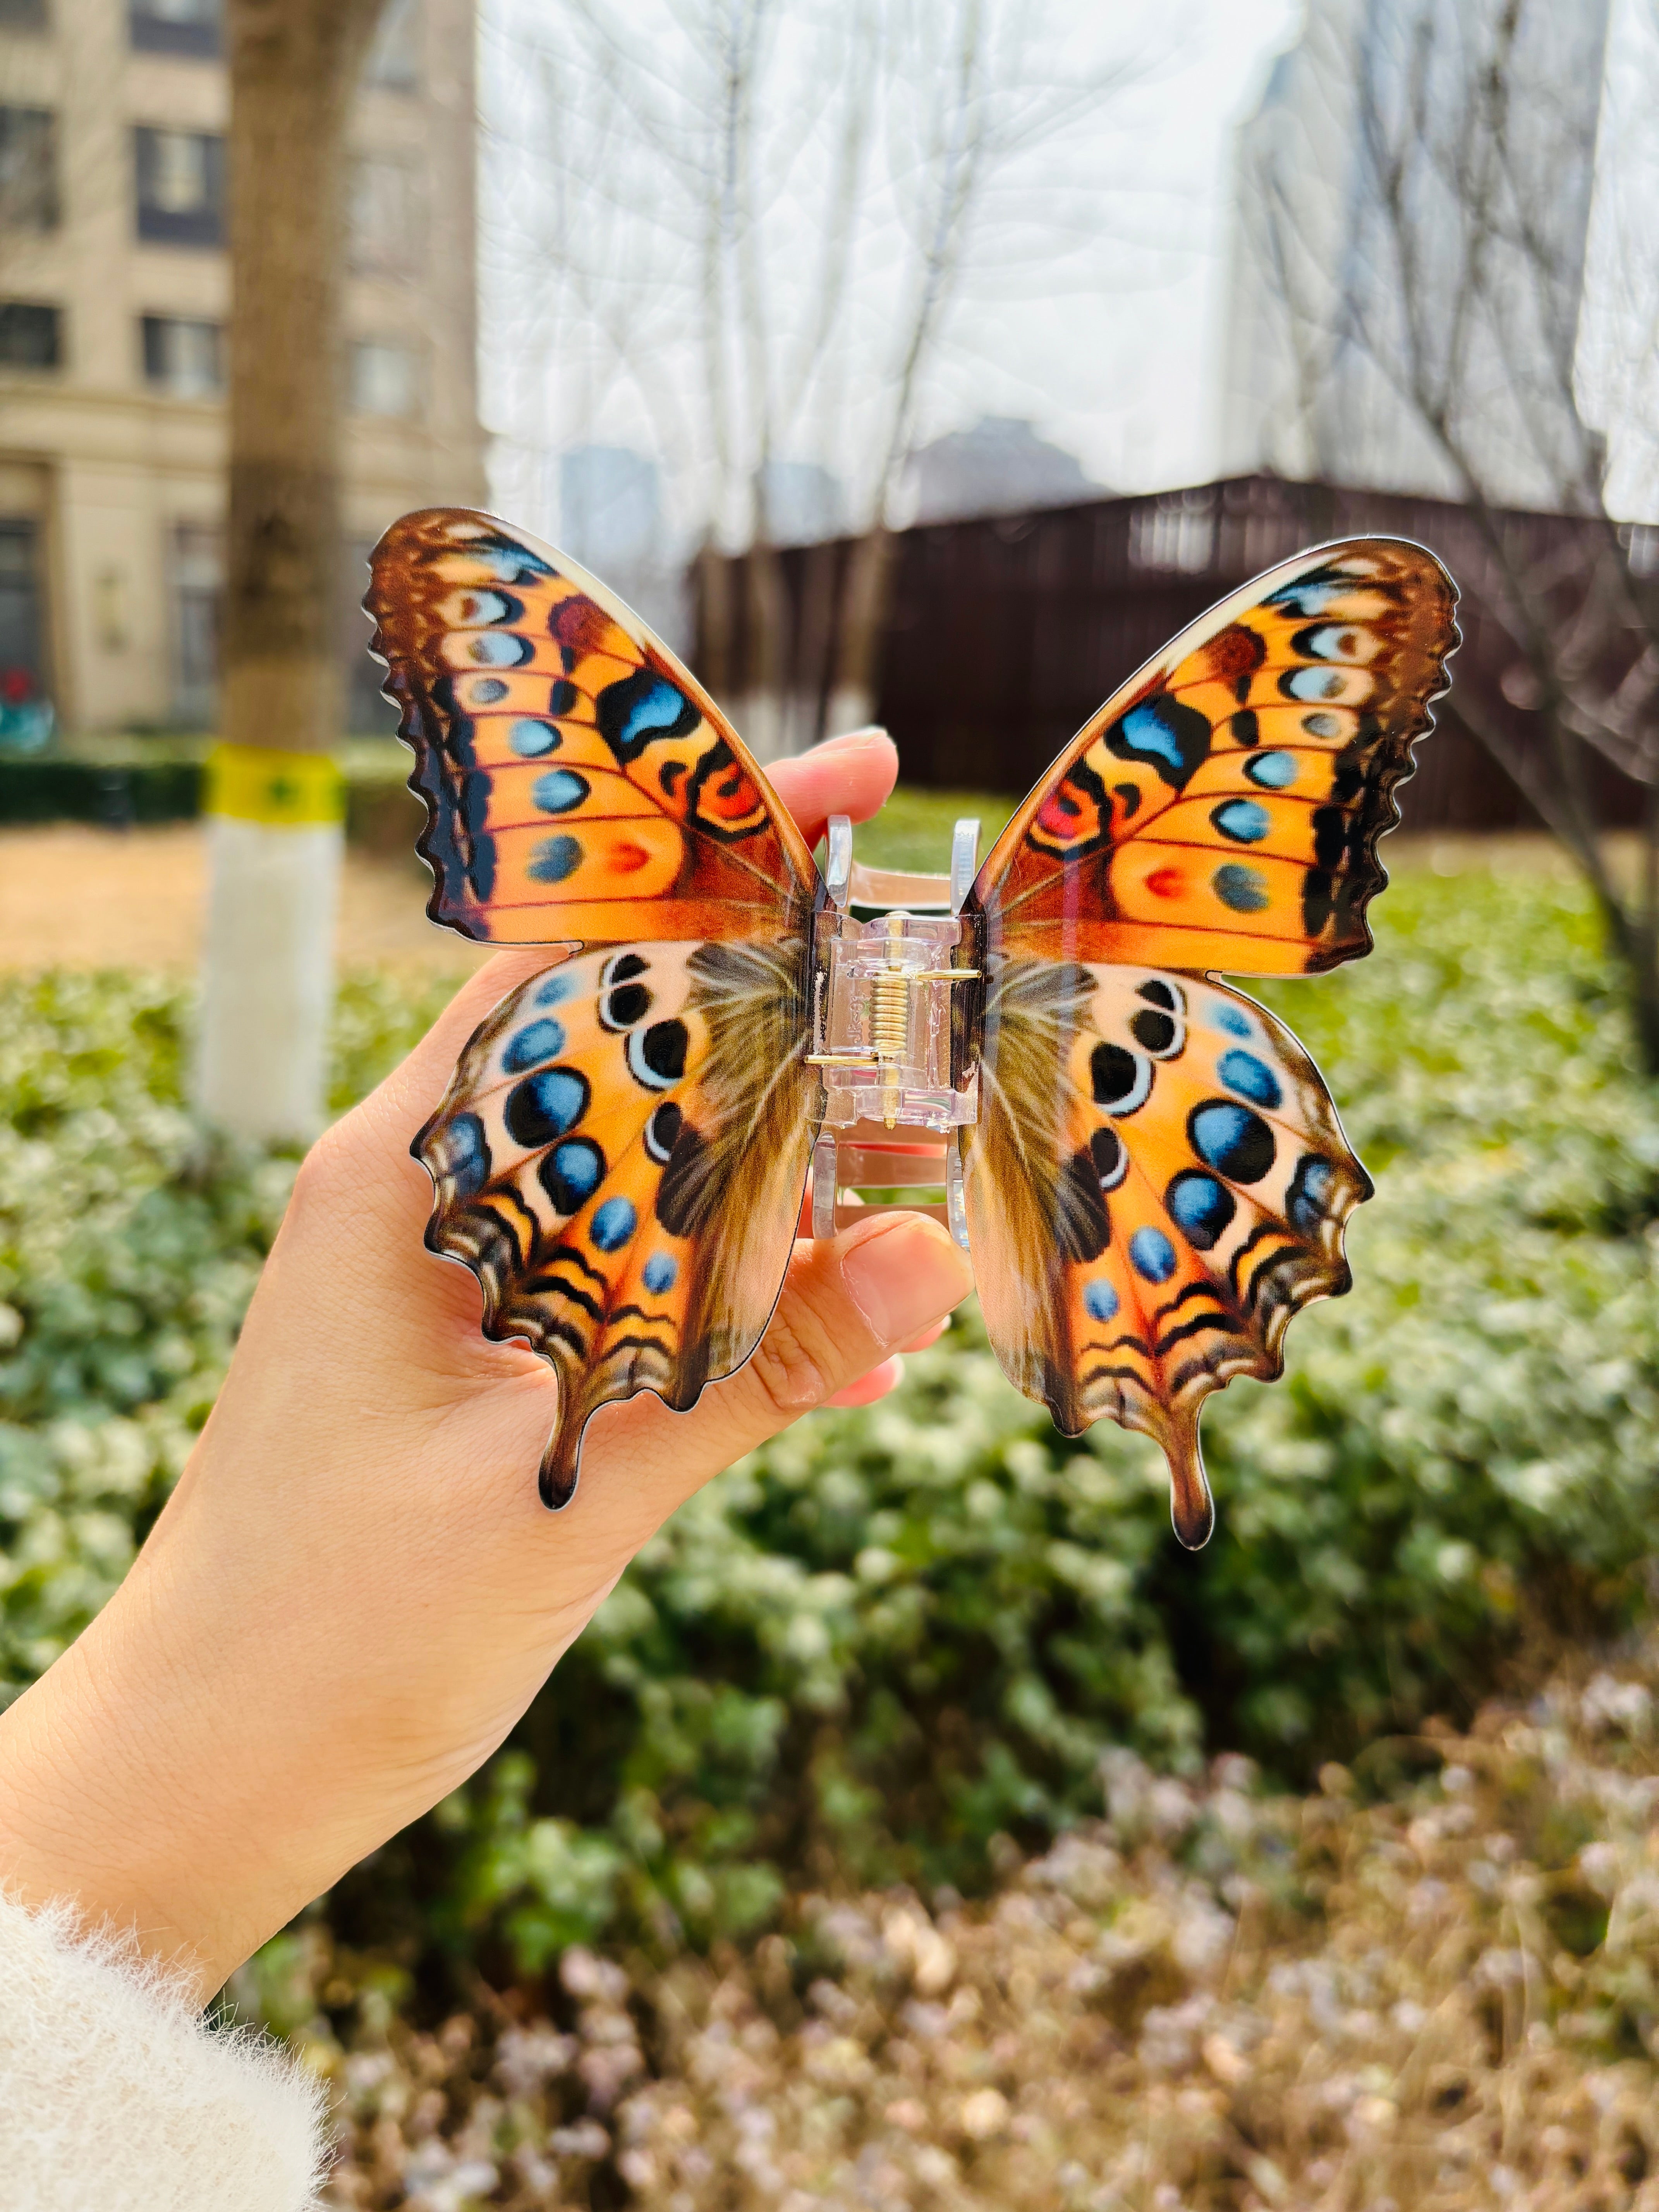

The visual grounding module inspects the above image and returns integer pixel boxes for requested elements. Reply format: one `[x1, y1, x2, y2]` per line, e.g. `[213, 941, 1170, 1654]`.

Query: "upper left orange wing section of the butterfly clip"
[365, 507, 814, 945]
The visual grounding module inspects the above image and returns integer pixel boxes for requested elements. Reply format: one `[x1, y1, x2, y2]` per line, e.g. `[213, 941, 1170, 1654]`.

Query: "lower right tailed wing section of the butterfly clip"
[962, 958, 1371, 1544]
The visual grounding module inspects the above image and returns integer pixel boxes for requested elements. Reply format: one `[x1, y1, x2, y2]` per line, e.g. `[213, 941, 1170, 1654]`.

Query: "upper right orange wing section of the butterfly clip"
[971, 538, 1458, 975]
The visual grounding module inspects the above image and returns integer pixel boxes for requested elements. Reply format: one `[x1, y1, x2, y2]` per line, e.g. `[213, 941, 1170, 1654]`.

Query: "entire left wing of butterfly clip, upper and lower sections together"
[367, 509, 821, 1506]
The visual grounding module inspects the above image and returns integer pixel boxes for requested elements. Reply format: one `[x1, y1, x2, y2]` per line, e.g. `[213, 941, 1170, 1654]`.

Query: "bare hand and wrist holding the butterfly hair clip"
[0, 737, 971, 2000]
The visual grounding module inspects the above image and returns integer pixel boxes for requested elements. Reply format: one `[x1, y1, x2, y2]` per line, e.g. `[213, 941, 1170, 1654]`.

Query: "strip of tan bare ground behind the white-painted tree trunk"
[0, 823, 484, 975]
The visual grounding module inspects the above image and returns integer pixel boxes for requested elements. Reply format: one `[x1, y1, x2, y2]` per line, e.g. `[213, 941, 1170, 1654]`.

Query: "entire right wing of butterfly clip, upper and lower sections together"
[962, 538, 1458, 1544]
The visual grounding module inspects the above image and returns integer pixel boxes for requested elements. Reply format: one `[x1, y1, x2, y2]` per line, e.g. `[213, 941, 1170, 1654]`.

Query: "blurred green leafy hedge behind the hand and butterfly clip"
[0, 849, 1659, 1971]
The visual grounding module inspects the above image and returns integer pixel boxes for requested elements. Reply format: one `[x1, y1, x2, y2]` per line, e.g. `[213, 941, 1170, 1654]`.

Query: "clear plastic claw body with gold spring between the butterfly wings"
[810, 814, 980, 1248]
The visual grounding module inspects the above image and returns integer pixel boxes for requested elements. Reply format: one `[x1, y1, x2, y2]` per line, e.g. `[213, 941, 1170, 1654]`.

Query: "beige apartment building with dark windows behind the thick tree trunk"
[0, 0, 482, 730]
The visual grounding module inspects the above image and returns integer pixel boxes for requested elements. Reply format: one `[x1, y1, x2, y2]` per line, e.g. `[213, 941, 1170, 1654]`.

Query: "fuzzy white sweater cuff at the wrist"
[0, 1896, 325, 2212]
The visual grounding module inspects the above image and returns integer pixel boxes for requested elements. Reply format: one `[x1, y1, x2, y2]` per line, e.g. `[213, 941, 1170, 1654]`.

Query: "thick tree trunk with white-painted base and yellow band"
[197, 0, 383, 1139]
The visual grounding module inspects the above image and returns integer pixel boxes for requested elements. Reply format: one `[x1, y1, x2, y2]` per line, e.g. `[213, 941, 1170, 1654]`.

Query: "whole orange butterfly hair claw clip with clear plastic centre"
[365, 509, 1458, 1546]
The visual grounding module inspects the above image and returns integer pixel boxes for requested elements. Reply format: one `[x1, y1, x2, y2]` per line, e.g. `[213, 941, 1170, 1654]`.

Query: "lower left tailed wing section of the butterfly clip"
[414, 942, 818, 1506]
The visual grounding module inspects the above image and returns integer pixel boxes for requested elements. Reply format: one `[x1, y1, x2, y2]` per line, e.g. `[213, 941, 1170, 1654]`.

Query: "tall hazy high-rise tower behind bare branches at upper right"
[1221, 0, 1608, 509]
